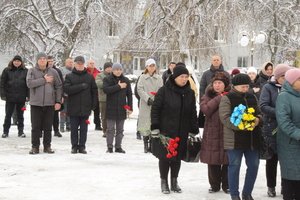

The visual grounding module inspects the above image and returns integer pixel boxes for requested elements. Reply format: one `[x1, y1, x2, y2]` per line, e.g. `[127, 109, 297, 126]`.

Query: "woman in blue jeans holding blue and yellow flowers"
[219, 74, 261, 200]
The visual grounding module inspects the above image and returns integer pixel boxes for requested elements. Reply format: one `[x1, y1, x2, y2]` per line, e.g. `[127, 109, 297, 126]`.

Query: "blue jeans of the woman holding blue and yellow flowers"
[227, 149, 259, 197]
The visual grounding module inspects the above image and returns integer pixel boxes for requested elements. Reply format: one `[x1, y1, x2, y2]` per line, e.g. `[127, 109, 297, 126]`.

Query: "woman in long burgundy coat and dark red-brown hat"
[200, 72, 230, 193]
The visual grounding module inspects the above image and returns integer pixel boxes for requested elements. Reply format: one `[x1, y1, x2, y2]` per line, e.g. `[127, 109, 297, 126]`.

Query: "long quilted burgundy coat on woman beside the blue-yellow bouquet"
[200, 86, 228, 165]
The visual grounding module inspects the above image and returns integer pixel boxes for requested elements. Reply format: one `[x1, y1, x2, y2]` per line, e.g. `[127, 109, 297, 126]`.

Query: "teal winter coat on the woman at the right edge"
[276, 82, 300, 181]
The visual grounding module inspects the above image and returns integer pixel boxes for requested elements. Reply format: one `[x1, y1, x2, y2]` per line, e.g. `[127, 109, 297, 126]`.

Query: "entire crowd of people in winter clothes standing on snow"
[0, 53, 300, 200]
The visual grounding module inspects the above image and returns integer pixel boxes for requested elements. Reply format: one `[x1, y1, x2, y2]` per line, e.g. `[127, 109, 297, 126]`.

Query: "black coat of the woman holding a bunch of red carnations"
[151, 76, 199, 160]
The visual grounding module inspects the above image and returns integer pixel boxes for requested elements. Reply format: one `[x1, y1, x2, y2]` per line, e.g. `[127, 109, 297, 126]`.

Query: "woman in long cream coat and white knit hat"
[137, 58, 163, 153]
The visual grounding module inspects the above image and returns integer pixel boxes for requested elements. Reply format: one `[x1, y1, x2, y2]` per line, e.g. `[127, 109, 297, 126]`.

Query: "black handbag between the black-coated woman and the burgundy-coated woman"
[183, 136, 202, 162]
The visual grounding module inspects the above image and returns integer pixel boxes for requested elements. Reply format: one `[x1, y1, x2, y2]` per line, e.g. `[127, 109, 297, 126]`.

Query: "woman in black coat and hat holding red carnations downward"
[151, 66, 199, 194]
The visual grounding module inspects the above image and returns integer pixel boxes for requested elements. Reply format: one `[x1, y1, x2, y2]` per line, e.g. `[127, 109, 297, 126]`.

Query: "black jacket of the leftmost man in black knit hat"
[0, 62, 29, 103]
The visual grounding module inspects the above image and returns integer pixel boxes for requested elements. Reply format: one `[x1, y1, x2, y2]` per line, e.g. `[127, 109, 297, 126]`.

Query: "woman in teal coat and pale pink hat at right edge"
[275, 68, 300, 200]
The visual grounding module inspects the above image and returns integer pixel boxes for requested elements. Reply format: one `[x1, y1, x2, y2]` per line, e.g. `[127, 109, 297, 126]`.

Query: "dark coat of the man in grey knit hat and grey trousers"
[103, 74, 132, 120]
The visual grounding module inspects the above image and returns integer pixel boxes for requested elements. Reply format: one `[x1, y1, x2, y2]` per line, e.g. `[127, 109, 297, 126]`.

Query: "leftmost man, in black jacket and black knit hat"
[0, 55, 29, 138]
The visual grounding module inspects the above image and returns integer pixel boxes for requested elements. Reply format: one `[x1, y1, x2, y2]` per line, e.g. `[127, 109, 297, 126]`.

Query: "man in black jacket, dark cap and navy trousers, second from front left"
[64, 56, 98, 154]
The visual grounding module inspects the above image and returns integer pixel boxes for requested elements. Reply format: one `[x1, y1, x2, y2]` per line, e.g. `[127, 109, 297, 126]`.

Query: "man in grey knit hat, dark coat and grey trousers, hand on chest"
[103, 63, 132, 153]
